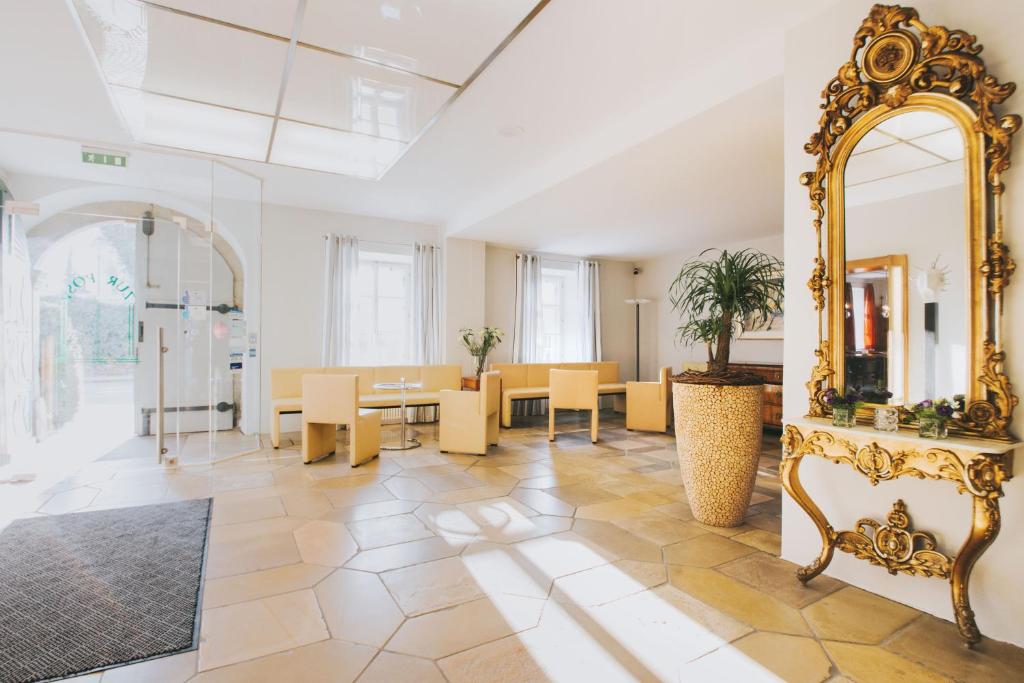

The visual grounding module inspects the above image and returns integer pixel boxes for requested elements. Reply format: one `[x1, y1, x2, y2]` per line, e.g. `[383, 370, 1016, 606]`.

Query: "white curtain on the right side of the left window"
[409, 244, 442, 422]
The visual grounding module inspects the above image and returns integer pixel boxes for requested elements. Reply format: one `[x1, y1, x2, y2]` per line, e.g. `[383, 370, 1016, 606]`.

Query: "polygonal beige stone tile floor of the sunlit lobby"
[0, 415, 1024, 683]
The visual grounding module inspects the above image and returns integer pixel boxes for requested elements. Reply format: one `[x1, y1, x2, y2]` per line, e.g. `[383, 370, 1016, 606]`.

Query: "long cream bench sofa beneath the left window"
[270, 366, 462, 449]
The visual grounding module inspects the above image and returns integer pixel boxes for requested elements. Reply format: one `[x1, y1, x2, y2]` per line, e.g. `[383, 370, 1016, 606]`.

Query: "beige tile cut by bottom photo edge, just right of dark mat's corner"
[193, 640, 377, 683]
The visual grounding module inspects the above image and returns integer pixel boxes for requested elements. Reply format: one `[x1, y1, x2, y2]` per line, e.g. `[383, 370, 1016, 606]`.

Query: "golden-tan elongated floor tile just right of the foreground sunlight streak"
[669, 566, 811, 636]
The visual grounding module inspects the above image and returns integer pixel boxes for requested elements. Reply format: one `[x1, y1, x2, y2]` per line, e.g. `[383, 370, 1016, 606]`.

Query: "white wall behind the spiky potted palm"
[631, 233, 782, 380]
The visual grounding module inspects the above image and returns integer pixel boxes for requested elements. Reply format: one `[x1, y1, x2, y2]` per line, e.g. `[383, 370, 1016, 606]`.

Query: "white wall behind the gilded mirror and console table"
[782, 0, 1024, 645]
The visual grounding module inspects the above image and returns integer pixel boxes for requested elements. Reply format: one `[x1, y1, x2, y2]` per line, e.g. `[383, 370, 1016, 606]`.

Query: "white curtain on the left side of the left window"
[321, 234, 359, 367]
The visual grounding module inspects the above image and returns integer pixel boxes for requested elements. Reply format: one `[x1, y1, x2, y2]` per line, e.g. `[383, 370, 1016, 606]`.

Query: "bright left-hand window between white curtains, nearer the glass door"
[351, 250, 413, 366]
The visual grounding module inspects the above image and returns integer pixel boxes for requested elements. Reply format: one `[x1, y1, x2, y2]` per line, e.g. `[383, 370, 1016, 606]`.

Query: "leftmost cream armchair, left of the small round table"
[302, 374, 381, 467]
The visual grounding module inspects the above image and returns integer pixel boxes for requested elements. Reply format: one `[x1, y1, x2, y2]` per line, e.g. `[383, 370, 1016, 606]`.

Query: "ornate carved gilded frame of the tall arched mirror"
[800, 5, 1021, 440]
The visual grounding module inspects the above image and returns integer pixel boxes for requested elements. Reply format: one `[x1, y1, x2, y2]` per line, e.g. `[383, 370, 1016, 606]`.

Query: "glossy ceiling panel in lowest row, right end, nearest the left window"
[270, 121, 407, 179]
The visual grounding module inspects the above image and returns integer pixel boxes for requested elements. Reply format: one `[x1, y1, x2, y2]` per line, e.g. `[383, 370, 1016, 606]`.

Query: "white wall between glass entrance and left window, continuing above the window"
[261, 204, 438, 432]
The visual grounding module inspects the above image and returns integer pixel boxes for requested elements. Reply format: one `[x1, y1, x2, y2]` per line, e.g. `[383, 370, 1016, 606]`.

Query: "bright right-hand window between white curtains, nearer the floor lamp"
[540, 263, 580, 362]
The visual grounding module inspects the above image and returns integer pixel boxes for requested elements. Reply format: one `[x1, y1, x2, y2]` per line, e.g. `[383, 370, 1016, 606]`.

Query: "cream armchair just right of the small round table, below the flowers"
[440, 372, 502, 456]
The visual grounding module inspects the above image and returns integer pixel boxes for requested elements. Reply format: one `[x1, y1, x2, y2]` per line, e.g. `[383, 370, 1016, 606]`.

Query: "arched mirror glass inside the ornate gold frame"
[844, 110, 970, 405]
